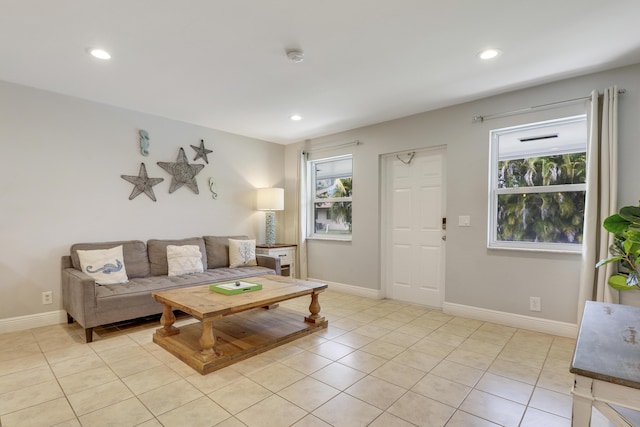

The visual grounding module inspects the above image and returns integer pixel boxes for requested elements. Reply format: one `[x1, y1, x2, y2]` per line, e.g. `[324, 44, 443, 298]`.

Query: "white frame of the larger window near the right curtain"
[487, 114, 587, 253]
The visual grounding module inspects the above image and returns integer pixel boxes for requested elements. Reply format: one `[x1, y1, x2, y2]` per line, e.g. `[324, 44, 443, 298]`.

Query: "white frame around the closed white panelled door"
[378, 145, 451, 308]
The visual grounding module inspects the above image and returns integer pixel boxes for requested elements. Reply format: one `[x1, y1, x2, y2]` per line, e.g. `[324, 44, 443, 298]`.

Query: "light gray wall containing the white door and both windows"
[285, 65, 640, 323]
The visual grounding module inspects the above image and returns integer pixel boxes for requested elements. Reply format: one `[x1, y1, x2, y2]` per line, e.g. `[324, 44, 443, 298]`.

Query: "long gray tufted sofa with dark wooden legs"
[61, 236, 280, 342]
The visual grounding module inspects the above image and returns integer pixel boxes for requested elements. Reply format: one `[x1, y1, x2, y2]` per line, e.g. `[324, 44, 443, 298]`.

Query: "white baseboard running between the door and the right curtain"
[442, 302, 578, 338]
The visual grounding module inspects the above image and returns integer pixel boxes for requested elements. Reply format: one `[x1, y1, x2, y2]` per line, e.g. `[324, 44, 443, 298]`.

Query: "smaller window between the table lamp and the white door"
[308, 155, 353, 240]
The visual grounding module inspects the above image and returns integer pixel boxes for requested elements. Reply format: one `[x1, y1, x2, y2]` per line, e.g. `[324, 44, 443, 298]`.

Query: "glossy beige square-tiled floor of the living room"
[0, 291, 610, 427]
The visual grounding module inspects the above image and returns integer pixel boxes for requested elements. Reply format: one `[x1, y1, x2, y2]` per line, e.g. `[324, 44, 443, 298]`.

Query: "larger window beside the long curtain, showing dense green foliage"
[488, 115, 587, 252]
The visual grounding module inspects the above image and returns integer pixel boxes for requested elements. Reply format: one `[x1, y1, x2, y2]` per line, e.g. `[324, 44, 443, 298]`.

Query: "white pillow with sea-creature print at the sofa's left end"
[78, 245, 129, 285]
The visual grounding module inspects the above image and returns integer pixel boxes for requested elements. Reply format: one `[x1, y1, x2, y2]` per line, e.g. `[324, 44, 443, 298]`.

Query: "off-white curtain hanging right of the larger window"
[578, 86, 619, 324]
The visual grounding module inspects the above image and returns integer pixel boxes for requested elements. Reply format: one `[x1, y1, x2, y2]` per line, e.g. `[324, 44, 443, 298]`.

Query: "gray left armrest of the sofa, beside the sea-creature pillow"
[60, 260, 97, 328]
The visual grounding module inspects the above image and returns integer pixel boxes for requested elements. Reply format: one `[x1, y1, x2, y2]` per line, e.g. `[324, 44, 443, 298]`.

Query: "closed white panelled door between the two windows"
[382, 148, 446, 307]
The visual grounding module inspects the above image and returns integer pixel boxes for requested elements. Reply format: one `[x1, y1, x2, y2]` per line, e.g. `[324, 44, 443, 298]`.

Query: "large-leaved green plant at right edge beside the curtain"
[596, 206, 640, 291]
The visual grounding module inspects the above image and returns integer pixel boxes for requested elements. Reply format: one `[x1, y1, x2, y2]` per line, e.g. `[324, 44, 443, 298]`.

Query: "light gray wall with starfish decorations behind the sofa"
[0, 82, 284, 319]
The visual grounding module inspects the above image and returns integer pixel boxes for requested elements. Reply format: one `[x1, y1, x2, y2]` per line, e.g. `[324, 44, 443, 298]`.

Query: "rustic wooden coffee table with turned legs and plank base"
[152, 275, 328, 374]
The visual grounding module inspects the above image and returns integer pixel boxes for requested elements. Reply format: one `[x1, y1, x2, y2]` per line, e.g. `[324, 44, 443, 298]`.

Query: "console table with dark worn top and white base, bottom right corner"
[570, 301, 640, 427]
